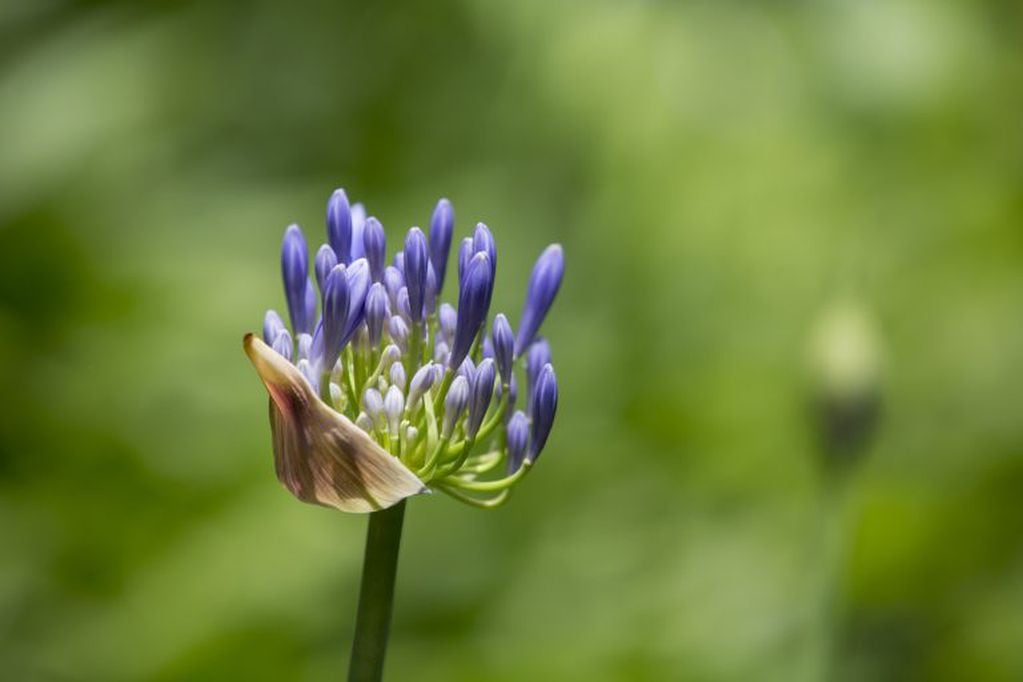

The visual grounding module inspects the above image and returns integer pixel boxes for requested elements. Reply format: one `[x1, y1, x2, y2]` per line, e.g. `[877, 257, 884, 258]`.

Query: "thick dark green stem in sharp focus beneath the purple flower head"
[348, 500, 405, 682]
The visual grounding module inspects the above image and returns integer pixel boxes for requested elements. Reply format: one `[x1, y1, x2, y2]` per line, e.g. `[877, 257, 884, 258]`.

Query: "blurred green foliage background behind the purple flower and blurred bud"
[0, 0, 1023, 682]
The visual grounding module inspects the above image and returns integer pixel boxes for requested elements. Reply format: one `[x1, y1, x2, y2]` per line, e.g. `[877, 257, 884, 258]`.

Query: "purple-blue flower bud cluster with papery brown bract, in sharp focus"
[244, 189, 565, 511]
